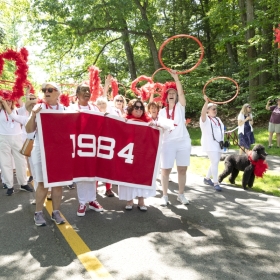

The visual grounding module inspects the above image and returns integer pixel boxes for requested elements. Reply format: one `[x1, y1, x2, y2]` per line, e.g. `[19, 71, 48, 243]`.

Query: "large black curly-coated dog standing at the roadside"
[219, 144, 267, 190]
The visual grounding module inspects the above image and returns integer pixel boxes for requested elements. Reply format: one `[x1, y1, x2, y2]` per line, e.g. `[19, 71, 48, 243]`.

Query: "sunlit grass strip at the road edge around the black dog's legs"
[188, 157, 280, 197]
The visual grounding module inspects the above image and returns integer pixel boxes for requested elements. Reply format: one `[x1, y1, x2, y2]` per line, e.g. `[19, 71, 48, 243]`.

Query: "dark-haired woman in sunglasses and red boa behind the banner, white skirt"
[119, 99, 156, 211]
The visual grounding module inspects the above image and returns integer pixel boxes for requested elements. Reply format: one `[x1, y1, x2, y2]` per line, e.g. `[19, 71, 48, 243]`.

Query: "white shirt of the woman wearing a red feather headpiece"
[158, 102, 190, 142]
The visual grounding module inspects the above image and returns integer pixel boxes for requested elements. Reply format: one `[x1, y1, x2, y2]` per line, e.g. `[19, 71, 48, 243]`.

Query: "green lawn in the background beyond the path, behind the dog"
[188, 127, 280, 156]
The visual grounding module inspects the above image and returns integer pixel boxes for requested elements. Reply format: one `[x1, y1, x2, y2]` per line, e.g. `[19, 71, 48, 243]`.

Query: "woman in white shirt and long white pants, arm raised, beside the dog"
[200, 95, 224, 192]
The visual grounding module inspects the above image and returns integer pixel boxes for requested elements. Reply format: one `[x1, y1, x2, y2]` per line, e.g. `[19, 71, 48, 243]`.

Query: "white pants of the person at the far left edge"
[0, 134, 27, 188]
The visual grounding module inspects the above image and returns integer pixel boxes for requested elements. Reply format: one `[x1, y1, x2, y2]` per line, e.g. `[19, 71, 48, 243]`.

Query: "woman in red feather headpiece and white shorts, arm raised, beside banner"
[159, 70, 191, 206]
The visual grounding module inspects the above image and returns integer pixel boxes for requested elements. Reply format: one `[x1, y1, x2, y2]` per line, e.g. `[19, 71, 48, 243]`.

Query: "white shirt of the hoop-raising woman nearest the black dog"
[199, 115, 224, 152]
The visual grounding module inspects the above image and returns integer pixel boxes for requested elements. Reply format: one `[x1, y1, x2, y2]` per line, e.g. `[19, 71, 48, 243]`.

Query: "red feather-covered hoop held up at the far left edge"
[0, 48, 28, 100]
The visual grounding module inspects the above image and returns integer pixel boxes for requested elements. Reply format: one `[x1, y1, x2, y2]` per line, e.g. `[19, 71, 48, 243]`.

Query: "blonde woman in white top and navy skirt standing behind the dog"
[237, 103, 255, 155]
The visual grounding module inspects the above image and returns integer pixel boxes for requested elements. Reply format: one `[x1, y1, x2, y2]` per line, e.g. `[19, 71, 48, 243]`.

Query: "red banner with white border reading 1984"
[38, 110, 162, 188]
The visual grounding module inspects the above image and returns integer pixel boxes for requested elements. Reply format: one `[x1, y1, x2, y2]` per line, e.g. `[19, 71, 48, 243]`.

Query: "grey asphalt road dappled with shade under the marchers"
[0, 148, 280, 280]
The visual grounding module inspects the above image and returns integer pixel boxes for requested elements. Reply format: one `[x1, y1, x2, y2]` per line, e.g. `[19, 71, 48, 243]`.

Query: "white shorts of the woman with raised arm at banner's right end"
[161, 140, 191, 169]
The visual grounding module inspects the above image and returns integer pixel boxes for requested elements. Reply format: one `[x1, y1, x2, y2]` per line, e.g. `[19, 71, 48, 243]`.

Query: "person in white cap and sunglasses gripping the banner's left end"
[25, 82, 65, 226]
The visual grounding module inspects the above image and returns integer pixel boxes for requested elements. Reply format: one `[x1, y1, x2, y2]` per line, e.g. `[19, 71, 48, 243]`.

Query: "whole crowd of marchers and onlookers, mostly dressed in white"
[0, 71, 280, 226]
